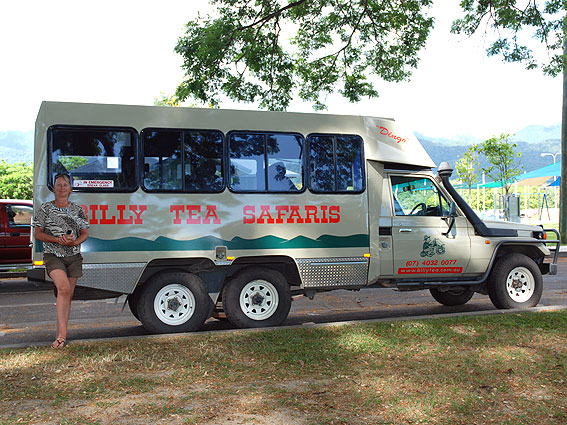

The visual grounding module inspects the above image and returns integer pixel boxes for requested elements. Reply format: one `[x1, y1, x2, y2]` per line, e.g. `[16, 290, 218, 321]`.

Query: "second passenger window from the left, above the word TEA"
[142, 129, 224, 192]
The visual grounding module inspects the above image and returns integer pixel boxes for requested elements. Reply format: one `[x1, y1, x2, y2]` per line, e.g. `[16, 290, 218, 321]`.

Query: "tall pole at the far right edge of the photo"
[559, 14, 567, 244]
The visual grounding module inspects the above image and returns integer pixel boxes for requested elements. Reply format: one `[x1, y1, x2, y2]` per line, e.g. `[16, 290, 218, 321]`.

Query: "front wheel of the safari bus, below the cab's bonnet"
[487, 254, 543, 308]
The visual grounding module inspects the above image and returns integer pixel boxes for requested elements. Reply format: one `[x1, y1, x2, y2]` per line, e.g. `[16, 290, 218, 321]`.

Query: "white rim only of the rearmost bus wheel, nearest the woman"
[154, 283, 195, 326]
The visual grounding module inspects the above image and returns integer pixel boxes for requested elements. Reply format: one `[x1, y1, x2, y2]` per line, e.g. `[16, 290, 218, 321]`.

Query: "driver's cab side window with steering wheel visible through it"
[391, 176, 449, 217]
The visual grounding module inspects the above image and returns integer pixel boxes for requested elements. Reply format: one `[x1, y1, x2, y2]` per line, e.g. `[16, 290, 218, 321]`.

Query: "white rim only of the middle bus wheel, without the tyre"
[240, 279, 279, 320]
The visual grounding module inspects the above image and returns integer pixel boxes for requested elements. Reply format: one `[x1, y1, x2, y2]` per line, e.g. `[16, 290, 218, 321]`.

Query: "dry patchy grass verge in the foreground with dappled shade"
[0, 311, 567, 425]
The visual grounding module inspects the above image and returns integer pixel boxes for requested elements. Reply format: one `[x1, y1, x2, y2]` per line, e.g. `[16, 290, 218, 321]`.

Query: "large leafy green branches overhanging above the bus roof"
[175, 0, 433, 110]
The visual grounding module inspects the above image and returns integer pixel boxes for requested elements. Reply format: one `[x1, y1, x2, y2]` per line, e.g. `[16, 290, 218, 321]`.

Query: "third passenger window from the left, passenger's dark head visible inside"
[229, 132, 303, 192]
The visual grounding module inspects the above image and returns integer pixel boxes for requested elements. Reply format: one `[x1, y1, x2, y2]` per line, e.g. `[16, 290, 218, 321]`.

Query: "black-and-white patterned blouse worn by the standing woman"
[33, 202, 89, 257]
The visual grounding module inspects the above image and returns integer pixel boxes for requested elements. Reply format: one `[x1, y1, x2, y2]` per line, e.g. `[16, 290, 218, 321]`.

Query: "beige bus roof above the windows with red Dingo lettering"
[36, 102, 435, 168]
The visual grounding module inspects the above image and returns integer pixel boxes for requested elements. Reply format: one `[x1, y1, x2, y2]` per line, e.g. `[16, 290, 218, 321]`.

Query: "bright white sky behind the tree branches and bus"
[0, 0, 562, 139]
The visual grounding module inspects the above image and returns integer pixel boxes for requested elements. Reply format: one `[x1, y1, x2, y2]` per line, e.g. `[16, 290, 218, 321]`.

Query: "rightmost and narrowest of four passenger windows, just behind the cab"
[308, 135, 364, 193]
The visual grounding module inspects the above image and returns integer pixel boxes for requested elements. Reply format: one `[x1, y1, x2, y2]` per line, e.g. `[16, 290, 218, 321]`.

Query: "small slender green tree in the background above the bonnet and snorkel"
[478, 134, 522, 200]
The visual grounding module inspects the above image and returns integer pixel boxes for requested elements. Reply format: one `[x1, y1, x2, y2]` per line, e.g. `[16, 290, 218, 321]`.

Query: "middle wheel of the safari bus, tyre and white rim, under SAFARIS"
[222, 269, 291, 328]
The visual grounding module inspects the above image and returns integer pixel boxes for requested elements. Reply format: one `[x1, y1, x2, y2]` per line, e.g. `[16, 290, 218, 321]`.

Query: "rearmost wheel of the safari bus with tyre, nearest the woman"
[137, 272, 212, 333]
